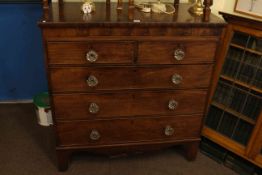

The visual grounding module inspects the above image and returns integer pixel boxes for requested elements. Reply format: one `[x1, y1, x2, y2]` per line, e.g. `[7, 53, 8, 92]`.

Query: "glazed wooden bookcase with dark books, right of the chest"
[203, 13, 262, 167]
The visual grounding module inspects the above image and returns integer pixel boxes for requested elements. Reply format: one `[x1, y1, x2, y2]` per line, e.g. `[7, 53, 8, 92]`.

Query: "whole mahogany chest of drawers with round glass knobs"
[39, 3, 225, 170]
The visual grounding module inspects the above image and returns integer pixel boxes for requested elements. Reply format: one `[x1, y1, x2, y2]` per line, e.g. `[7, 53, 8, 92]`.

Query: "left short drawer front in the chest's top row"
[47, 41, 134, 64]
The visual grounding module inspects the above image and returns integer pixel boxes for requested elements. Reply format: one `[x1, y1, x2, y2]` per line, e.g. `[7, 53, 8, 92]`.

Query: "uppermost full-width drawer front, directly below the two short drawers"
[50, 65, 212, 92]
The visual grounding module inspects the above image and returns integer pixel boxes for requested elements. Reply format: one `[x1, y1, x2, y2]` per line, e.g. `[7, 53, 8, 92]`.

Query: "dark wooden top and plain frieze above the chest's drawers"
[39, 2, 226, 37]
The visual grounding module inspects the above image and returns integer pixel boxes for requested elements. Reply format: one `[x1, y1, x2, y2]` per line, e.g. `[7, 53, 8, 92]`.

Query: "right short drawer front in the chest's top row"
[138, 41, 216, 64]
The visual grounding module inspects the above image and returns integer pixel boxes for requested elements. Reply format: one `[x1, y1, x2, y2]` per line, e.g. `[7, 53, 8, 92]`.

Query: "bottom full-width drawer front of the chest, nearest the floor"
[57, 115, 202, 146]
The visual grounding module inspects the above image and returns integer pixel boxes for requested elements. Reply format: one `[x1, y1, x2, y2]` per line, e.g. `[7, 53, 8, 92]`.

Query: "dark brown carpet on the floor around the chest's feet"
[0, 104, 236, 175]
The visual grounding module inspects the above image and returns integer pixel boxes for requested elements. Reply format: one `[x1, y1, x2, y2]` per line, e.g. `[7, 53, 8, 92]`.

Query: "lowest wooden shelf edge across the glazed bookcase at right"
[211, 101, 256, 125]
